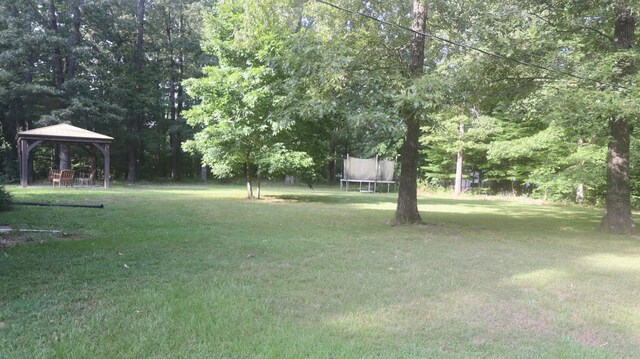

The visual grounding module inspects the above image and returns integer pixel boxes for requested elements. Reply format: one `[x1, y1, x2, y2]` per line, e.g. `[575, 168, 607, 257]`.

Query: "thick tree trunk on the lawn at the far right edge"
[598, 3, 636, 234]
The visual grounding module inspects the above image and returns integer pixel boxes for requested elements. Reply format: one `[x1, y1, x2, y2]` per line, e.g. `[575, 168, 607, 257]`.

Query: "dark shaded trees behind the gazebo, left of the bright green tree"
[0, 0, 209, 182]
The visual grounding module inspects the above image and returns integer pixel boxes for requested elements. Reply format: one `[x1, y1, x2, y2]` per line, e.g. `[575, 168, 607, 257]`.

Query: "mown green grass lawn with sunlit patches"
[0, 186, 640, 358]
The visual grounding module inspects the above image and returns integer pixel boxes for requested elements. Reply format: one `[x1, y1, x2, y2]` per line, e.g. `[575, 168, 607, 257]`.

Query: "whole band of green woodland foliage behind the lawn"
[0, 0, 640, 206]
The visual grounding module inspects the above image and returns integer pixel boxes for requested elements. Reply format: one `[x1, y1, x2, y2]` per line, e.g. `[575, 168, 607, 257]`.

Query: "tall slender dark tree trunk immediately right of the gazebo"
[127, 0, 145, 183]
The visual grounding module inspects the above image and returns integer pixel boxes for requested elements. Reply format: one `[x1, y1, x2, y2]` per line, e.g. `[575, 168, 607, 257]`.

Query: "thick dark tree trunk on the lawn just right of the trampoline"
[394, 0, 428, 224]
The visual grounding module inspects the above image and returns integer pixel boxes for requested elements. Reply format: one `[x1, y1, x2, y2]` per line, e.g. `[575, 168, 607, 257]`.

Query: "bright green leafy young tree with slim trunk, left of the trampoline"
[185, 1, 314, 199]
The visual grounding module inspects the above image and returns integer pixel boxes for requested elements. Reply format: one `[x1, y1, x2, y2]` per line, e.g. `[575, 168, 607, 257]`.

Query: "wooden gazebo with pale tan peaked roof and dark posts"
[18, 124, 113, 188]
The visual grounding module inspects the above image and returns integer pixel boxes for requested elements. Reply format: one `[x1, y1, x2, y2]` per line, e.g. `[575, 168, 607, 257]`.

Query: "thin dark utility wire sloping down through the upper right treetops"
[315, 0, 625, 89]
